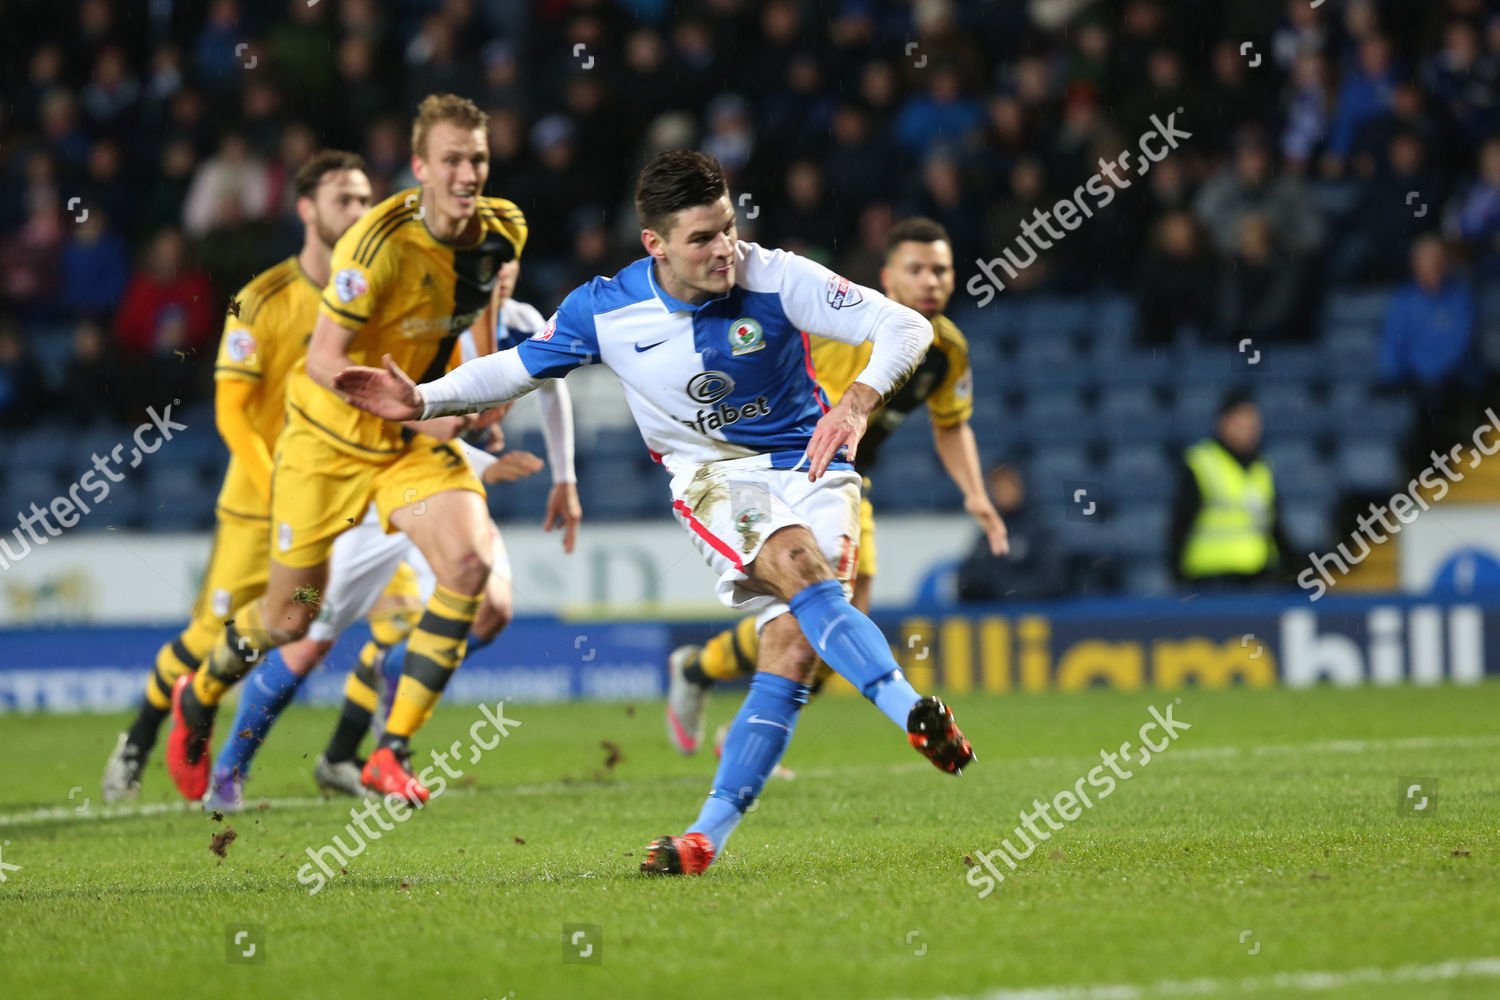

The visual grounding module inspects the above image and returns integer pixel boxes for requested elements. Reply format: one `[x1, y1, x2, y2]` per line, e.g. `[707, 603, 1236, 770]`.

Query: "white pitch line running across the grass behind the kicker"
[0, 735, 1500, 826]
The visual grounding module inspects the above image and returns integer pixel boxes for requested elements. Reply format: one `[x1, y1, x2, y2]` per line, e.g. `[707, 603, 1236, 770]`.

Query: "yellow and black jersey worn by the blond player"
[287, 187, 527, 462]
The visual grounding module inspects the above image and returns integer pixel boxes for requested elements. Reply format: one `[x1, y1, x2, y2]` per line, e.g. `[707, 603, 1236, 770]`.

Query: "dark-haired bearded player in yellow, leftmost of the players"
[104, 150, 371, 802]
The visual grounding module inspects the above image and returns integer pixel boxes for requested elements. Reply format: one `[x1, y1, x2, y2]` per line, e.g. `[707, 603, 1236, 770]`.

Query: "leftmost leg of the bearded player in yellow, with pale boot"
[102, 513, 270, 802]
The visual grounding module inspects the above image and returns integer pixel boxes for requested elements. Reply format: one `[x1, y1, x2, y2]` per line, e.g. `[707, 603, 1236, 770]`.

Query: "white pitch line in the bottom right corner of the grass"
[906, 958, 1500, 1000]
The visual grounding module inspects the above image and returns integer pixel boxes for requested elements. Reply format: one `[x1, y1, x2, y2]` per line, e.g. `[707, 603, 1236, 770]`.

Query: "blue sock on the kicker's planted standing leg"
[687, 673, 809, 855]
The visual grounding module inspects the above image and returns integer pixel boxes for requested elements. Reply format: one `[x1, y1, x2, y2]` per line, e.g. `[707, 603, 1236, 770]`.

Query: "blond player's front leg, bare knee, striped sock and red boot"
[365, 489, 494, 802]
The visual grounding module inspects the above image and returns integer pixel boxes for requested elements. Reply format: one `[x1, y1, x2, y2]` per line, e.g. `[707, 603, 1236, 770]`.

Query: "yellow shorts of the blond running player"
[272, 420, 485, 567]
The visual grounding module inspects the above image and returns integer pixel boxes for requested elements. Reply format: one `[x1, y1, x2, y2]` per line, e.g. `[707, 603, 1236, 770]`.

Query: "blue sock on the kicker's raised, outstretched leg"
[791, 580, 921, 732]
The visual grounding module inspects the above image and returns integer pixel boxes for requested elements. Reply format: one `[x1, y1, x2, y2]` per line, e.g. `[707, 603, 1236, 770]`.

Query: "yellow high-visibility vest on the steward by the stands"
[1182, 439, 1277, 577]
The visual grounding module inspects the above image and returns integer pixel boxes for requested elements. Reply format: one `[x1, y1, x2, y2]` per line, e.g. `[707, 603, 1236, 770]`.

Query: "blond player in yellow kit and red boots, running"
[167, 94, 578, 802]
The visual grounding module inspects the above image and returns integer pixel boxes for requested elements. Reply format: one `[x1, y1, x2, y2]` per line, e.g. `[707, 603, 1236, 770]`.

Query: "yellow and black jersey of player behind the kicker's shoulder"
[812, 315, 974, 472]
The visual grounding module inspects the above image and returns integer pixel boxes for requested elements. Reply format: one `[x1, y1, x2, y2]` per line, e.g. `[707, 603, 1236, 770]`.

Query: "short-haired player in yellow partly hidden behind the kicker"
[666, 217, 1008, 755]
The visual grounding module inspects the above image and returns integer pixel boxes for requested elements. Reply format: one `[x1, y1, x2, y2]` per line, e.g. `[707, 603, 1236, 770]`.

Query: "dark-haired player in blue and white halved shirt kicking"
[333, 150, 974, 874]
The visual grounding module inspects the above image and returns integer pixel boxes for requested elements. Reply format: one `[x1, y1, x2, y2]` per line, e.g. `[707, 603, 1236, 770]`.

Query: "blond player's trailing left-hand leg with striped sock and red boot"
[167, 559, 327, 799]
